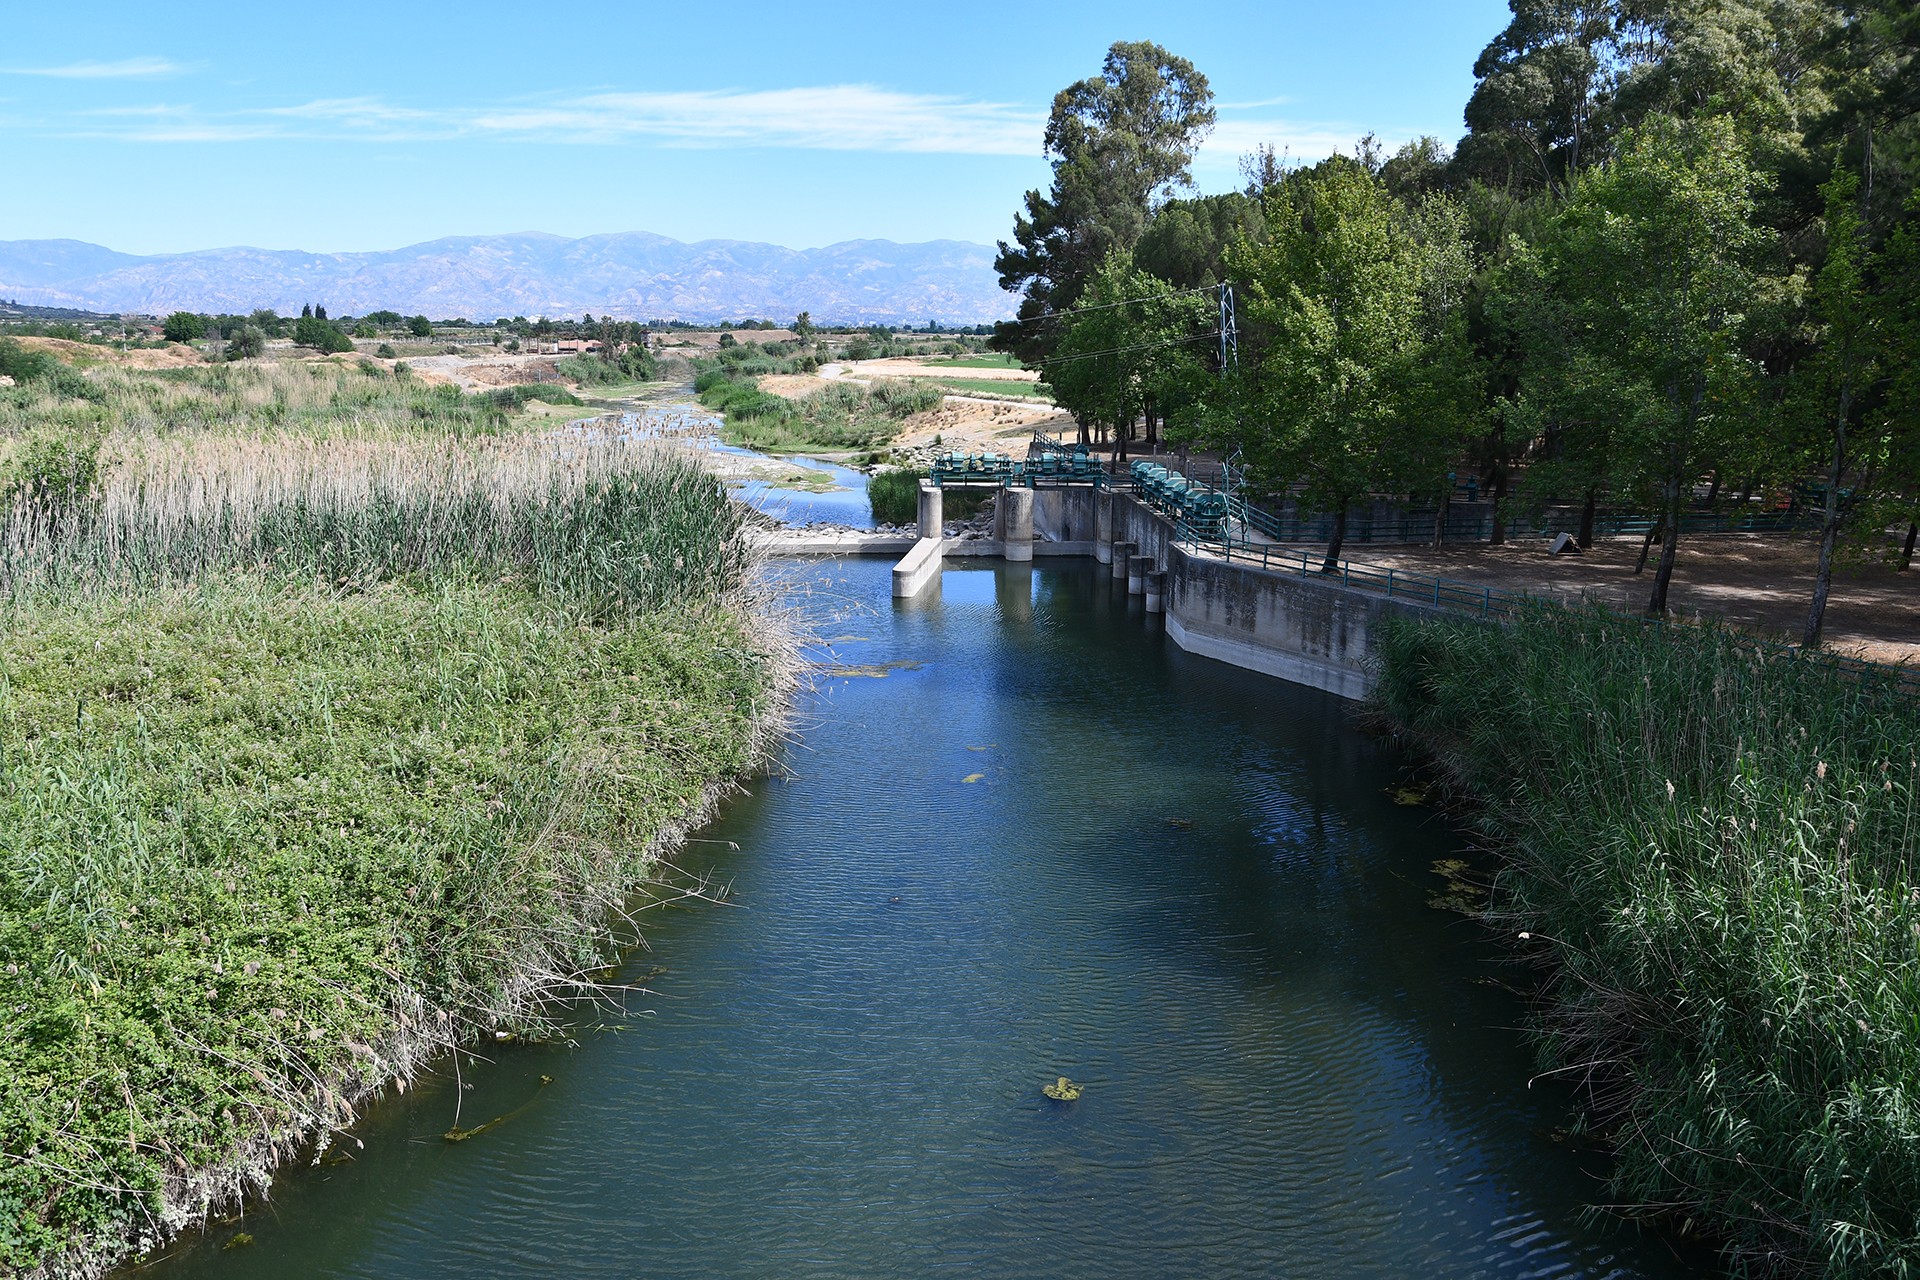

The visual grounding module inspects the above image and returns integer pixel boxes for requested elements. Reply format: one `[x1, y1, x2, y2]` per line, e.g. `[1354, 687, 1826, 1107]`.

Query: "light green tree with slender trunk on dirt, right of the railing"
[1523, 115, 1768, 614]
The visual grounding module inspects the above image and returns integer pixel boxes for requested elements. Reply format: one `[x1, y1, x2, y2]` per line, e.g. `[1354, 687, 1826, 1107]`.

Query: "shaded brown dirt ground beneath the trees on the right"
[1344, 533, 1920, 662]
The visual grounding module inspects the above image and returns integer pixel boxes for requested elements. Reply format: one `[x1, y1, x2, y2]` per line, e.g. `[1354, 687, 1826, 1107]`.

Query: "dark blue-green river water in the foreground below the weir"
[150, 560, 1697, 1278]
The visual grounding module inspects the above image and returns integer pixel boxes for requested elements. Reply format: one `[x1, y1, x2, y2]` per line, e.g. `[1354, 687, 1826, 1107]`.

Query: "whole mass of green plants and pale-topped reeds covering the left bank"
[0, 355, 787, 1274]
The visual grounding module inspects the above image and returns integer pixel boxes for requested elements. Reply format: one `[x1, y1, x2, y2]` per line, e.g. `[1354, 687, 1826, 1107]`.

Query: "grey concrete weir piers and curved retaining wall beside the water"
[893, 480, 1438, 699]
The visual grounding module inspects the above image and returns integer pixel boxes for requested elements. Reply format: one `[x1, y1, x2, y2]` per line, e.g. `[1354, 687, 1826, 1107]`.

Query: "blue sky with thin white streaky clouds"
[0, 0, 1507, 253]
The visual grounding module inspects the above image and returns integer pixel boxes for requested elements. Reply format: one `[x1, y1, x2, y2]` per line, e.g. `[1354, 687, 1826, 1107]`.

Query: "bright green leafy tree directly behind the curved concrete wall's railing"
[1210, 155, 1471, 572]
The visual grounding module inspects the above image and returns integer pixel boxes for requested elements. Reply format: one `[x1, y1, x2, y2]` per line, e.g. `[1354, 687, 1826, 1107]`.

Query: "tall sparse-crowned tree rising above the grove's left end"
[995, 40, 1213, 361]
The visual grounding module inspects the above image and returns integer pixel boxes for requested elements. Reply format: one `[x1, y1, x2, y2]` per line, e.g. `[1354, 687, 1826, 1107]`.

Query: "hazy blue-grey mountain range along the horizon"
[0, 232, 1014, 324]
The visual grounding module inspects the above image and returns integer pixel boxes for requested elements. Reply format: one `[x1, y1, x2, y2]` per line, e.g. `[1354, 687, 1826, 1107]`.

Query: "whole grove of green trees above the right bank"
[995, 18, 1920, 645]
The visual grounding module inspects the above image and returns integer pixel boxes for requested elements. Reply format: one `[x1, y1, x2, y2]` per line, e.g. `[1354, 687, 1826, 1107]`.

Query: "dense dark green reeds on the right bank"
[1379, 610, 1920, 1276]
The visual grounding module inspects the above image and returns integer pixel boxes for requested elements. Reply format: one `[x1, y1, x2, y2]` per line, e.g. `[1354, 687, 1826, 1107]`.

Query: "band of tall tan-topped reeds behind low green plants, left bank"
[0, 436, 749, 618]
